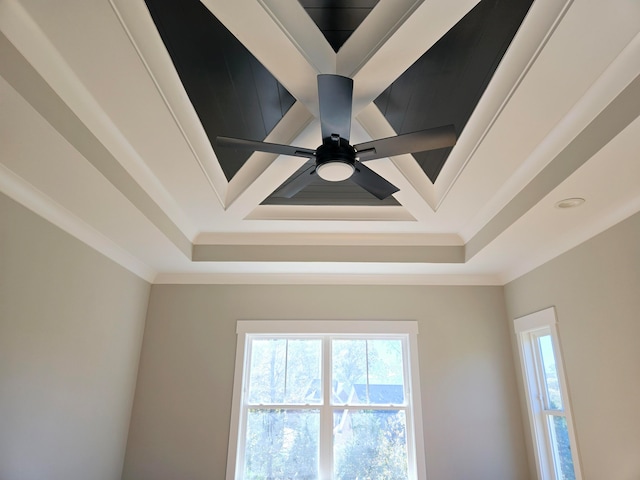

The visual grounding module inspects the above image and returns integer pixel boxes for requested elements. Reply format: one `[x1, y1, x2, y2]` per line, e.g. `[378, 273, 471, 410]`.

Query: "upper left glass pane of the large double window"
[247, 338, 322, 405]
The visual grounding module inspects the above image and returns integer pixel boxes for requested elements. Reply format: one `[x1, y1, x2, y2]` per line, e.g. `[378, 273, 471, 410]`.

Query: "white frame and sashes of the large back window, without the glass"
[227, 321, 425, 480]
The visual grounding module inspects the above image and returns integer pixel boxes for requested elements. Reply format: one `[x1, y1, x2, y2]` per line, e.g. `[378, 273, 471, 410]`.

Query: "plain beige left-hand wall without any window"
[0, 195, 150, 480]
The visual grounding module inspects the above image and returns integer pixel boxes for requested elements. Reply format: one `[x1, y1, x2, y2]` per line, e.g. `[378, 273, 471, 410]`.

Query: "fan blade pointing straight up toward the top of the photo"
[318, 75, 353, 142]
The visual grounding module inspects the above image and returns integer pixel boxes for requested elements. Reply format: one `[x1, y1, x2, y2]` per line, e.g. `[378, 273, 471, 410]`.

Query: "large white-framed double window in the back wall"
[227, 321, 425, 480]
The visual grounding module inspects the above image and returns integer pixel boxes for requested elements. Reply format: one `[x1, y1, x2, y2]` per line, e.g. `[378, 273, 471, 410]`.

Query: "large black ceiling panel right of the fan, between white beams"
[375, 0, 532, 182]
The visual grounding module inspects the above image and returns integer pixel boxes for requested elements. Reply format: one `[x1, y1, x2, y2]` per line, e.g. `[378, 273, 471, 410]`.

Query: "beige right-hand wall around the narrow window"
[505, 214, 640, 480]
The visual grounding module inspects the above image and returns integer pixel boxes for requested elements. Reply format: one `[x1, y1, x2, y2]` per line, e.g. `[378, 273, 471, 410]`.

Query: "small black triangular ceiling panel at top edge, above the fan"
[299, 0, 379, 52]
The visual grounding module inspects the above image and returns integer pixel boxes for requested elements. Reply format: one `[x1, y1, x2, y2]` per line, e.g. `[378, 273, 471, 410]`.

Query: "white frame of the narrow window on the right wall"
[514, 307, 582, 480]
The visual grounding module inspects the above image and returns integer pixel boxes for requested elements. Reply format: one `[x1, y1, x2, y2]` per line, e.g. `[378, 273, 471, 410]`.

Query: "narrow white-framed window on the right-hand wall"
[515, 308, 581, 480]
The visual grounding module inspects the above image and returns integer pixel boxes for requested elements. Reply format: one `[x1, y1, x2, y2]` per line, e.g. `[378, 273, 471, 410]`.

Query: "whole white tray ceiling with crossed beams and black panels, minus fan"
[0, 0, 640, 284]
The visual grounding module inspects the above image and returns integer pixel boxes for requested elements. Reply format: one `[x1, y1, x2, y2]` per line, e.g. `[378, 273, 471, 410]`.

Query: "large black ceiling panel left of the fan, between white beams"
[145, 0, 295, 180]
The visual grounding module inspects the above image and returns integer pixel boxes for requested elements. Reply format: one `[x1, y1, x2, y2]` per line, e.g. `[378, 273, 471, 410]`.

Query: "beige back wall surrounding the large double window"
[123, 285, 529, 480]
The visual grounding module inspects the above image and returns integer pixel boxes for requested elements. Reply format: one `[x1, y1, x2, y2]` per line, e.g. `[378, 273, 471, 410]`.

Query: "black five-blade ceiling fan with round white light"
[216, 74, 456, 200]
